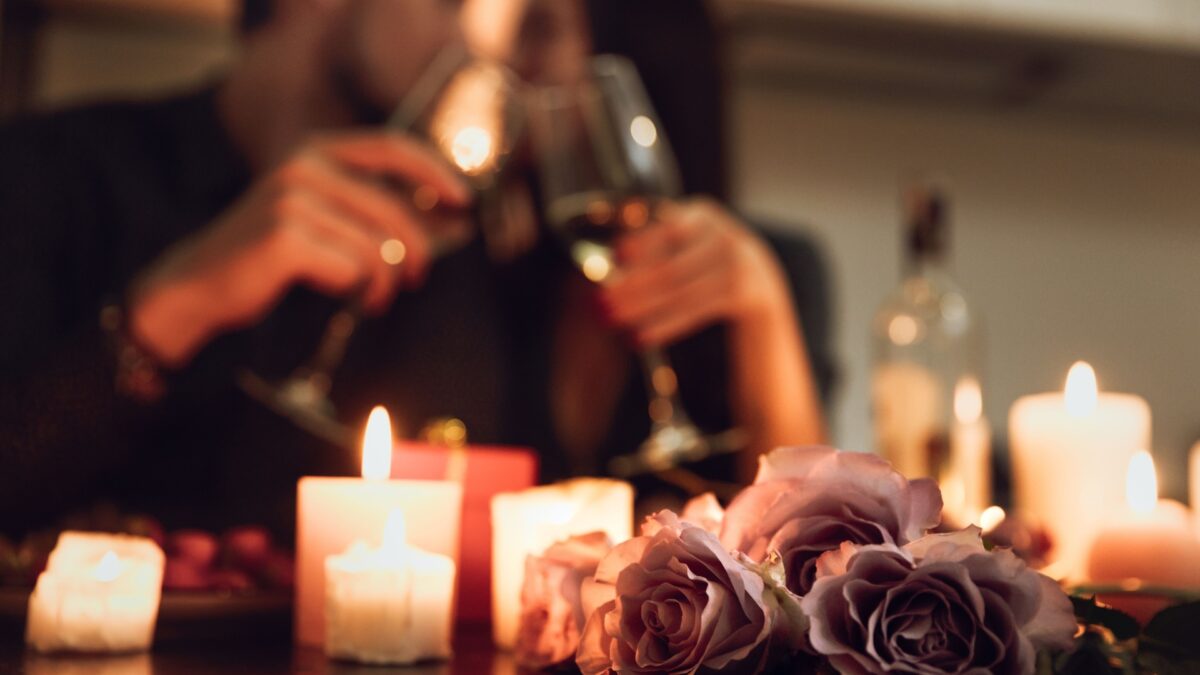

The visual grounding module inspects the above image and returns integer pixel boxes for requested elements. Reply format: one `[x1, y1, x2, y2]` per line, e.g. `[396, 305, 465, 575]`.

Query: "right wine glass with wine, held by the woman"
[529, 55, 725, 476]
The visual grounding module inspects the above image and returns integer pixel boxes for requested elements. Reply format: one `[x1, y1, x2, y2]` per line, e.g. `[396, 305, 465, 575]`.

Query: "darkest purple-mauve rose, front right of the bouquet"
[800, 528, 1075, 675]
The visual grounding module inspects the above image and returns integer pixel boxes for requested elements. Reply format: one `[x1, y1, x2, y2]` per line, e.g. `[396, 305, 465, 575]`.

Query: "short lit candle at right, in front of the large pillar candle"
[1087, 452, 1200, 621]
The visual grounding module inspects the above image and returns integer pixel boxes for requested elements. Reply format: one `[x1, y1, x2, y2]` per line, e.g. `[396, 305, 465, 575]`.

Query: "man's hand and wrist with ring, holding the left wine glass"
[128, 132, 470, 366]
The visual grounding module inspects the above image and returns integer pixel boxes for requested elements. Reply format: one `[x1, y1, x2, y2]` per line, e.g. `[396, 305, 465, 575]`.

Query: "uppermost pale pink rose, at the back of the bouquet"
[721, 447, 942, 596]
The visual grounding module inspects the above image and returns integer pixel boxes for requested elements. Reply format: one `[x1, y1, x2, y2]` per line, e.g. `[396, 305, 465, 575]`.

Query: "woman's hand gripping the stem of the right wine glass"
[600, 198, 788, 347]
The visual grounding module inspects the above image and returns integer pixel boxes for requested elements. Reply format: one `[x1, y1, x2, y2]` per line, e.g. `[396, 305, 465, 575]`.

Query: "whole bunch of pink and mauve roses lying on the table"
[517, 447, 1078, 675]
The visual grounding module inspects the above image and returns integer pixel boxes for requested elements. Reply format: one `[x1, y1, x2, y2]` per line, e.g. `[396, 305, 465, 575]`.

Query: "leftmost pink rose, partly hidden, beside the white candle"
[516, 532, 612, 668]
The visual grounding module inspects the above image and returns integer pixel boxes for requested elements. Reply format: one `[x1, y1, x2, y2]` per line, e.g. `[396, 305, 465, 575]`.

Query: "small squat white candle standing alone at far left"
[25, 532, 164, 652]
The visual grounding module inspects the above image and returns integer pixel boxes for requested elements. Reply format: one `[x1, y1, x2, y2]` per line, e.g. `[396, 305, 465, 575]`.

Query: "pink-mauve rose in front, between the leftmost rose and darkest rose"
[576, 510, 803, 675]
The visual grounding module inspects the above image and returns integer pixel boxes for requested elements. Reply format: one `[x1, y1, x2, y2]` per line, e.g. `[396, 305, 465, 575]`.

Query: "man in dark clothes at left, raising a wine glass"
[0, 0, 482, 530]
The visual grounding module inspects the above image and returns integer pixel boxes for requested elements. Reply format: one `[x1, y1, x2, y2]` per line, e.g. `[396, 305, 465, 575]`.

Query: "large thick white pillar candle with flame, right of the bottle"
[1008, 362, 1150, 579]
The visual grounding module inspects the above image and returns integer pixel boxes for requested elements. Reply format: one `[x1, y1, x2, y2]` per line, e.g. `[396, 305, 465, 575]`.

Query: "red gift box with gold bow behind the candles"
[391, 441, 538, 621]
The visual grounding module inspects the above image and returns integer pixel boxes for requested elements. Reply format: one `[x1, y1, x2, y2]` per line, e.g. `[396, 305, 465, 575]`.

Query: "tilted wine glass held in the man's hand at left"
[238, 44, 524, 444]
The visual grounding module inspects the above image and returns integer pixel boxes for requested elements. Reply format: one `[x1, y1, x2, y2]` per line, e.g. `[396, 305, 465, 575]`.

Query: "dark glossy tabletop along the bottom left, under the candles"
[0, 626, 518, 675]
